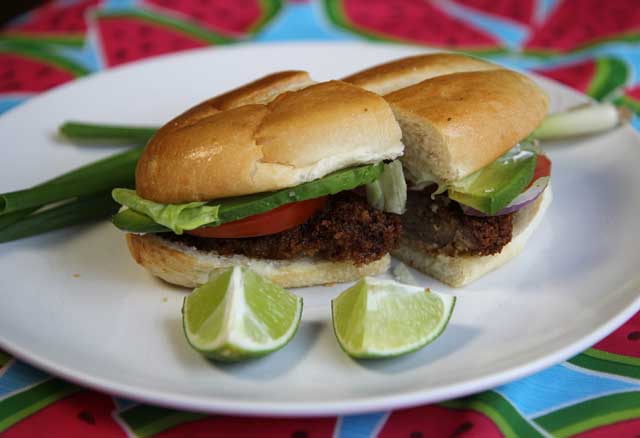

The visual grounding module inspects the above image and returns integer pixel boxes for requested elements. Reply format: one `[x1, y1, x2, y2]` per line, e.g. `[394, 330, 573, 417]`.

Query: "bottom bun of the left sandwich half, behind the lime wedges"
[127, 234, 391, 288]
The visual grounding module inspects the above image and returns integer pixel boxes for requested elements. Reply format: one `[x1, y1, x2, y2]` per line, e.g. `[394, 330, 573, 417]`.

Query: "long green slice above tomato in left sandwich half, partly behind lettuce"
[112, 163, 383, 233]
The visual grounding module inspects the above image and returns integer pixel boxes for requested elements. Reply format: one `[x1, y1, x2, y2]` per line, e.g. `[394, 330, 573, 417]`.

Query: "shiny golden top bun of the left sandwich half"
[136, 81, 403, 203]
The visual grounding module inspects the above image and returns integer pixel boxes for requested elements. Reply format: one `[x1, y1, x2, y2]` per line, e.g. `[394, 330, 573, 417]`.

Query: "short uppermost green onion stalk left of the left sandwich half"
[59, 121, 158, 144]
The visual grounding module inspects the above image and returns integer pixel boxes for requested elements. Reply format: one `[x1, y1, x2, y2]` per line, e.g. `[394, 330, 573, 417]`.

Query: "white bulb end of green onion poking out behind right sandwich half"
[529, 103, 628, 140]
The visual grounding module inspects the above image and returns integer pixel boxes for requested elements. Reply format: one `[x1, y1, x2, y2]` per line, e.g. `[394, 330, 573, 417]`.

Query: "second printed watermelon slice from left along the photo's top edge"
[144, 0, 281, 36]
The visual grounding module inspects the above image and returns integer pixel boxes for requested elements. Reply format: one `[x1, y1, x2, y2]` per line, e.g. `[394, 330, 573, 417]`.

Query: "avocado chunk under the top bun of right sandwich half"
[448, 150, 538, 215]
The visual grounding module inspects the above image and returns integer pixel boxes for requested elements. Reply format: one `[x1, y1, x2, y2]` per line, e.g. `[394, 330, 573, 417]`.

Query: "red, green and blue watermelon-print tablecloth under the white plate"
[0, 0, 640, 438]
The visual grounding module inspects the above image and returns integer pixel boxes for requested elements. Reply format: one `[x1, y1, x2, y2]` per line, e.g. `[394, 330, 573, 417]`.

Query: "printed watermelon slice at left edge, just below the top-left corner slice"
[0, 44, 88, 93]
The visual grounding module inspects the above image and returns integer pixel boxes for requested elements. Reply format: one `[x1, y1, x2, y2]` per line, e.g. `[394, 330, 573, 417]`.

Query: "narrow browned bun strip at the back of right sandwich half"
[343, 53, 500, 94]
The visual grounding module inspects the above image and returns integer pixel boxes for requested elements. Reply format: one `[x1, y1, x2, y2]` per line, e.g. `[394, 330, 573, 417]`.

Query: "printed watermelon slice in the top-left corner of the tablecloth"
[3, 0, 101, 46]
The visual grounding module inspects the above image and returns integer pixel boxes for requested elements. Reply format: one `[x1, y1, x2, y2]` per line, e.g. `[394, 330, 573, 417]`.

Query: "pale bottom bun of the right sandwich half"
[393, 187, 553, 287]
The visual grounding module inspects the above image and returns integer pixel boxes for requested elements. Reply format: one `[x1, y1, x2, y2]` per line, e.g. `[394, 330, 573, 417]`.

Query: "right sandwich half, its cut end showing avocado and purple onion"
[345, 54, 552, 287]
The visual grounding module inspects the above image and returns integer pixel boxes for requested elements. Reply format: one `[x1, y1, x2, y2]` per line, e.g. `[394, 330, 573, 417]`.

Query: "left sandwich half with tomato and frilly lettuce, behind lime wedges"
[107, 72, 403, 287]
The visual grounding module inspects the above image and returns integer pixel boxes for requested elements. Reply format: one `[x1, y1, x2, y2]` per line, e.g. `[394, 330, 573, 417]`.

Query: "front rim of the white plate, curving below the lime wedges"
[0, 283, 640, 417]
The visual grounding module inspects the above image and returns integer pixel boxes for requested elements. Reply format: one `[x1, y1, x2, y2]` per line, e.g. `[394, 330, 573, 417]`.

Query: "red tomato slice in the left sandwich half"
[185, 196, 327, 238]
